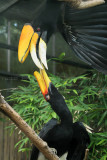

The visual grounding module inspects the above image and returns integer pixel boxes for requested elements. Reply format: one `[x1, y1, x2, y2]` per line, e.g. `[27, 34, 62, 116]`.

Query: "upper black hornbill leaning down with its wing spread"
[18, 0, 107, 74]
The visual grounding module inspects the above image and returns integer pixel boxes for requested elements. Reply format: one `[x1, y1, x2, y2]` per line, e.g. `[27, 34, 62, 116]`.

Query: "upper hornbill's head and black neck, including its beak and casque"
[18, 0, 61, 69]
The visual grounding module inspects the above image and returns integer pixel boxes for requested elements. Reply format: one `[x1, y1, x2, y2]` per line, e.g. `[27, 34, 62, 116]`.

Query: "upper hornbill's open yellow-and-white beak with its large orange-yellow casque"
[18, 24, 48, 69]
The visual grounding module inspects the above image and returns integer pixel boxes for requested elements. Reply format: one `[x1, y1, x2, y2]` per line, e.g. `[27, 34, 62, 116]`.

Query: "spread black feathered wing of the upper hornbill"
[59, 1, 107, 74]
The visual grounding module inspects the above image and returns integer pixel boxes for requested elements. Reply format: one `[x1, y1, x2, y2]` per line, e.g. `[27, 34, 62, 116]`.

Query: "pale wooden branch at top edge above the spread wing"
[59, 0, 105, 9]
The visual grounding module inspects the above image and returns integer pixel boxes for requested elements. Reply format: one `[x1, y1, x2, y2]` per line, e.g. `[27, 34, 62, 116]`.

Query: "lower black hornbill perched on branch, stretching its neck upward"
[30, 69, 90, 160]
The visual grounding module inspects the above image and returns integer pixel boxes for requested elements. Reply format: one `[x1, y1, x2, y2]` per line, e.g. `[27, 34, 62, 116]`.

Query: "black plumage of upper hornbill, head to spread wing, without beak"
[32, 0, 107, 74]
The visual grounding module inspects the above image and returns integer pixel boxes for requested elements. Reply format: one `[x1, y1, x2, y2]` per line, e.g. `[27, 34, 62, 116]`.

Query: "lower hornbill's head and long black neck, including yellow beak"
[34, 68, 72, 119]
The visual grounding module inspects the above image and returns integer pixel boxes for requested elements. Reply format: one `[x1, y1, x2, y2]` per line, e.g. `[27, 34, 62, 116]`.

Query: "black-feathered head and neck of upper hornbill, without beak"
[32, 0, 62, 42]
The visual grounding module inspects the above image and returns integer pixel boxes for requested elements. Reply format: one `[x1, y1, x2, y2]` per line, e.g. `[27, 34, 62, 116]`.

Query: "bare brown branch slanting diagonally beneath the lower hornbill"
[0, 93, 59, 160]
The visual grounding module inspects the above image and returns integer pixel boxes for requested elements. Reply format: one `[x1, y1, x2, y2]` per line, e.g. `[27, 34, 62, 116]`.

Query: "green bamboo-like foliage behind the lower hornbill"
[9, 73, 107, 160]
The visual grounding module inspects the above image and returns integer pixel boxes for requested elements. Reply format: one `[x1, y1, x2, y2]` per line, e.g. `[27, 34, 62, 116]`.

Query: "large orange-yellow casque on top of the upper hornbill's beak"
[18, 24, 34, 63]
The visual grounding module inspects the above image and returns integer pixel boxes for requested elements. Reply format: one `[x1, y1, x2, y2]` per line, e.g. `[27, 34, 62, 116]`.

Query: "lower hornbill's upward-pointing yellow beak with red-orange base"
[34, 68, 51, 101]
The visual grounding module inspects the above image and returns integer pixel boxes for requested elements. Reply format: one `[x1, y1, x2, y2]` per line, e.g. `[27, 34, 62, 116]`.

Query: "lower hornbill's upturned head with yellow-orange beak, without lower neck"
[34, 67, 65, 105]
